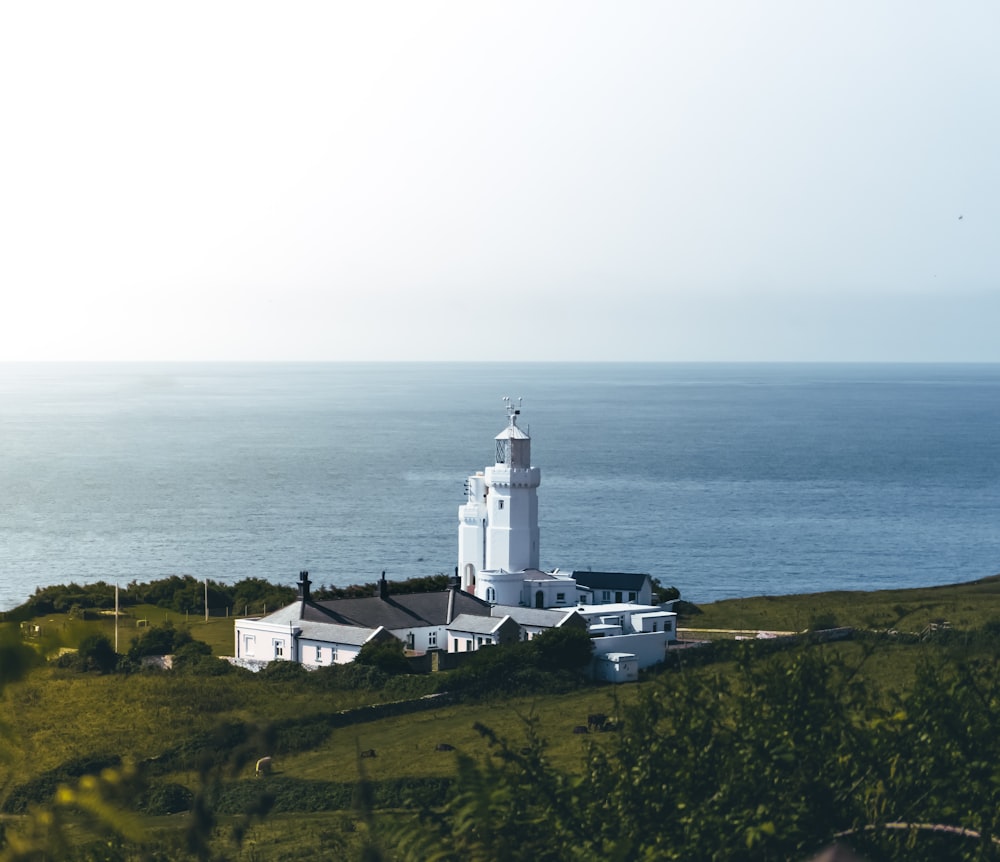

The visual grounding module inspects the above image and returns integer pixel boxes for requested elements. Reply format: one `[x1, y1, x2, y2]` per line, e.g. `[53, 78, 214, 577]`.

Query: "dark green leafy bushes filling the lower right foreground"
[393, 648, 1000, 862]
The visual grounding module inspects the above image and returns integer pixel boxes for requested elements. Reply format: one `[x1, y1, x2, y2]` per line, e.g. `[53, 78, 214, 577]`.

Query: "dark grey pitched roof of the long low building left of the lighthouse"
[301, 590, 490, 629]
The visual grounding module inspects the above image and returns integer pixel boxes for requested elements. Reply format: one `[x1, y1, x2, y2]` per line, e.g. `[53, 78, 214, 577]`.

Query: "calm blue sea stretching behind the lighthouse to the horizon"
[0, 363, 1000, 609]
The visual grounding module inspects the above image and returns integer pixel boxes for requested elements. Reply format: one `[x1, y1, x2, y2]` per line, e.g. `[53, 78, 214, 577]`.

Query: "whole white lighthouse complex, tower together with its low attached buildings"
[230, 398, 676, 678]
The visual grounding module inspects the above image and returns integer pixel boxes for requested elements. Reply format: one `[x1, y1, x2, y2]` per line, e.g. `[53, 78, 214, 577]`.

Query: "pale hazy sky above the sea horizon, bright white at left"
[0, 0, 1000, 362]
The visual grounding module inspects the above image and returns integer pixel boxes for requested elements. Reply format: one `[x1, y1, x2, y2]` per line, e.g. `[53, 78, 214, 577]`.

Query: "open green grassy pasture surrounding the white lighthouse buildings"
[0, 577, 1000, 859]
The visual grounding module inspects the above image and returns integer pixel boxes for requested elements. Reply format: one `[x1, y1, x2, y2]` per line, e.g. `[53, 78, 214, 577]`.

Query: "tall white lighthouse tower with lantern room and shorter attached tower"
[458, 398, 541, 605]
